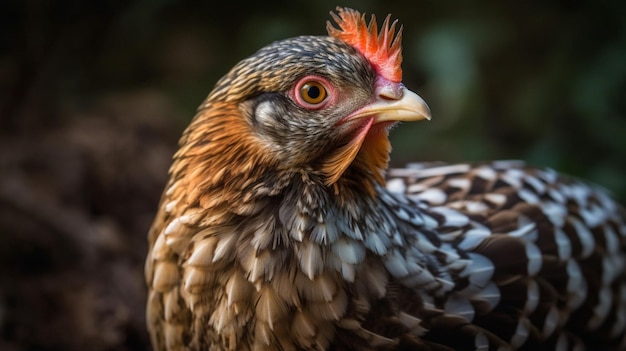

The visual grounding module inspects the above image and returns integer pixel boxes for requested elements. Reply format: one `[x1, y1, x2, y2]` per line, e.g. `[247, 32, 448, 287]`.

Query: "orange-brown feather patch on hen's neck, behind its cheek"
[170, 103, 278, 212]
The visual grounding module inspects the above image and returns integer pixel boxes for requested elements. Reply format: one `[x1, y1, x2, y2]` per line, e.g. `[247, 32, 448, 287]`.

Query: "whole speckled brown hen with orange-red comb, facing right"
[146, 8, 626, 350]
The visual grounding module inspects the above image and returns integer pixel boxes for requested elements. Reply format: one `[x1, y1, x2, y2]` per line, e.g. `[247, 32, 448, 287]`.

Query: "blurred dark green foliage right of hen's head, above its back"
[394, 1, 626, 201]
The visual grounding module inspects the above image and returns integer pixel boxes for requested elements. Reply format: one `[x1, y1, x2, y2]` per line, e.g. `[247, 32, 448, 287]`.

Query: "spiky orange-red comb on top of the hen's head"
[326, 7, 402, 82]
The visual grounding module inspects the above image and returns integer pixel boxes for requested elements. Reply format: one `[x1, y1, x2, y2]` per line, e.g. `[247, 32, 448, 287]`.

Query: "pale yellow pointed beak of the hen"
[348, 87, 431, 123]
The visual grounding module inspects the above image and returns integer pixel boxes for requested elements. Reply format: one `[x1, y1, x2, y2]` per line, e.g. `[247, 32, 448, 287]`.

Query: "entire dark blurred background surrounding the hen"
[0, 0, 626, 350]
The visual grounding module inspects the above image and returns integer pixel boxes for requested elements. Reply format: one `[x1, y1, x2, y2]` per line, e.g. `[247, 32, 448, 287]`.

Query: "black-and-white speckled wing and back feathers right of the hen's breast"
[387, 161, 626, 350]
